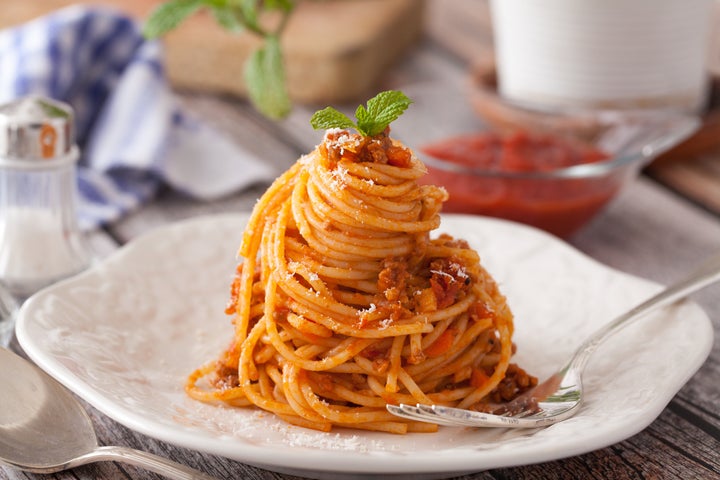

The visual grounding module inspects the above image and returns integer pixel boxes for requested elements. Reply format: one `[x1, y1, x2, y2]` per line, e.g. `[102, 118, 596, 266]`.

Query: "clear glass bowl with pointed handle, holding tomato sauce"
[415, 111, 700, 238]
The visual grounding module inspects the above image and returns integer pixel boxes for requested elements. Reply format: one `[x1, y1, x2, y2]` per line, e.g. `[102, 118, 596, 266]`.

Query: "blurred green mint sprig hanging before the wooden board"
[143, 0, 296, 119]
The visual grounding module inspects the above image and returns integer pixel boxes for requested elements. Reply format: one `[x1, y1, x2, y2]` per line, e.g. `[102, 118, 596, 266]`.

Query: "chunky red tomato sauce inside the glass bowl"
[420, 132, 624, 237]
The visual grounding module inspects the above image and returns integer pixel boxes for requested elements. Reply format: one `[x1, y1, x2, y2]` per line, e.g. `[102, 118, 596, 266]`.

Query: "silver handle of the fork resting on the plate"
[568, 254, 720, 371]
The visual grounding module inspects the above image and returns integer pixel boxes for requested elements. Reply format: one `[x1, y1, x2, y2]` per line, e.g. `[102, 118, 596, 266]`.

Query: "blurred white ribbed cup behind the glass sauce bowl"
[490, 0, 713, 112]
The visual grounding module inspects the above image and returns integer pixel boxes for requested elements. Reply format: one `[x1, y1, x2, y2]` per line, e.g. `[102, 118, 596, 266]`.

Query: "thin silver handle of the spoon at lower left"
[66, 447, 217, 480]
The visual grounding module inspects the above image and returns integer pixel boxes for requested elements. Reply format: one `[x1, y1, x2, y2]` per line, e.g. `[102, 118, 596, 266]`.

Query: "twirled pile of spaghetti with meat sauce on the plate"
[186, 125, 535, 433]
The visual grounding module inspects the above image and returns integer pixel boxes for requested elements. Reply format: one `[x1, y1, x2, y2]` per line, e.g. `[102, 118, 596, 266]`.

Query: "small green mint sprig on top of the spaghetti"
[310, 90, 412, 137]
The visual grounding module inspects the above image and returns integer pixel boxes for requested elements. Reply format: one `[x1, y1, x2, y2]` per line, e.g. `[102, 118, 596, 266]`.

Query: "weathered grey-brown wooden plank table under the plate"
[0, 0, 720, 480]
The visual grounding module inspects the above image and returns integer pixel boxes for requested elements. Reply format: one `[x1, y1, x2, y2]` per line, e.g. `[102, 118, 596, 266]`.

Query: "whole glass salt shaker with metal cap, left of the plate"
[0, 96, 91, 299]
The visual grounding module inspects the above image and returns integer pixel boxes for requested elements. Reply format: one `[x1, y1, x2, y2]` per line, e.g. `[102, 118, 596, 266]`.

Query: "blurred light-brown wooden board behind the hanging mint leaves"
[0, 0, 425, 103]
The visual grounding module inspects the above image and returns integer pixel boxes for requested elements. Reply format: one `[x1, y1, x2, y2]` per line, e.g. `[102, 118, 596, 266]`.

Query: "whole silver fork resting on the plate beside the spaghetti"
[387, 255, 720, 428]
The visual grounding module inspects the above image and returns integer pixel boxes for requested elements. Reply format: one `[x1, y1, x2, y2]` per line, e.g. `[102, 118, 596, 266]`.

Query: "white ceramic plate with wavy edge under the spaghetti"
[17, 215, 712, 478]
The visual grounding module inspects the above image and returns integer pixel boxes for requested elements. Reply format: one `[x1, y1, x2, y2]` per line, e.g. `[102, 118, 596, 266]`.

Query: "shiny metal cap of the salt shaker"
[0, 95, 77, 168]
